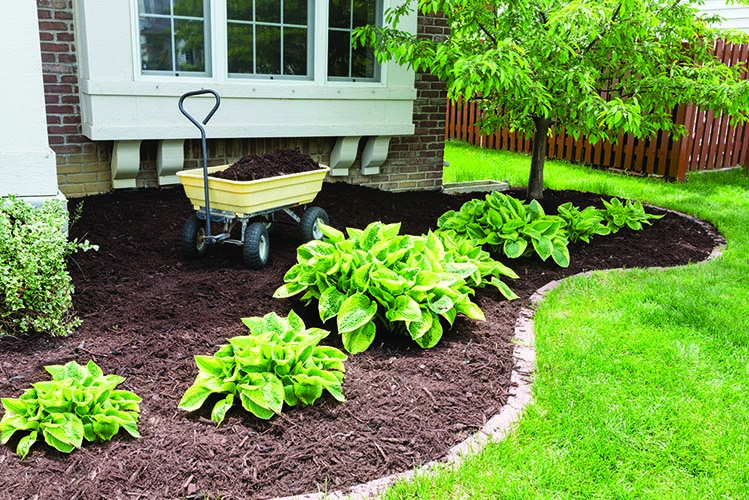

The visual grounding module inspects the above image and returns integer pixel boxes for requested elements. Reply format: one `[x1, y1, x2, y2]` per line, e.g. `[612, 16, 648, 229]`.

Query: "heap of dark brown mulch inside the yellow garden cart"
[209, 148, 320, 181]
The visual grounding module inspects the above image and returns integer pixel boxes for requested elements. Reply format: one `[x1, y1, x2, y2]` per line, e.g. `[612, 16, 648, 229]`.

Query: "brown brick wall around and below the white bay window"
[37, 4, 447, 198]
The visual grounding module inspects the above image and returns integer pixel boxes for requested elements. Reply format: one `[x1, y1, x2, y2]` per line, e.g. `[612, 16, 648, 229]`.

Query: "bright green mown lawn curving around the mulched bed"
[383, 143, 749, 500]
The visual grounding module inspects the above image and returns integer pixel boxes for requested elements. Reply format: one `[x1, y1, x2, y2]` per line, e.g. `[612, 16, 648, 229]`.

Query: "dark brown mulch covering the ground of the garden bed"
[0, 178, 716, 500]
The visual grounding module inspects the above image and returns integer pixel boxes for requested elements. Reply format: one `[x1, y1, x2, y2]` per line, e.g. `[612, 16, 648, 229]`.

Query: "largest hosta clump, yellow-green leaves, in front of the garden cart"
[274, 222, 517, 354]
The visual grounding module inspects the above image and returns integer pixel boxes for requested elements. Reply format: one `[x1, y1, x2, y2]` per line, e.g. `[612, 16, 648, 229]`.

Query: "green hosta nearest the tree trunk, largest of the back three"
[437, 191, 570, 267]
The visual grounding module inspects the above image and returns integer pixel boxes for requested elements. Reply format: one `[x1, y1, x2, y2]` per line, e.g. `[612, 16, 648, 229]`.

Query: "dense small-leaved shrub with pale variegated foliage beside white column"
[0, 196, 97, 335]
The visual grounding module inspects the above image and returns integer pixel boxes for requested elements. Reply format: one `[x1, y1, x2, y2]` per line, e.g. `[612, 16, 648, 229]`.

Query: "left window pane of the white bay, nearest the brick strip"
[138, 0, 210, 76]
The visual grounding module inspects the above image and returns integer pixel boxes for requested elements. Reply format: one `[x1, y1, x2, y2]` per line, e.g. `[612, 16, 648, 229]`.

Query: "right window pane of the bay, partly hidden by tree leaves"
[328, 0, 382, 81]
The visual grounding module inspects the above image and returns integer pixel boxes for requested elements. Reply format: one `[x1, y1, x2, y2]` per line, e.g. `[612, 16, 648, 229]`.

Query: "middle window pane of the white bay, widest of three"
[226, 0, 313, 79]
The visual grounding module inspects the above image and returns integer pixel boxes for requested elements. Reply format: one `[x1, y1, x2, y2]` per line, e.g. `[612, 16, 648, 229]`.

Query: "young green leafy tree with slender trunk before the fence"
[356, 0, 749, 198]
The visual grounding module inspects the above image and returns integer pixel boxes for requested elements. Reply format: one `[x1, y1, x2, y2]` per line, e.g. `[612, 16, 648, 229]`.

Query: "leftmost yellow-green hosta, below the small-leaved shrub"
[0, 361, 141, 458]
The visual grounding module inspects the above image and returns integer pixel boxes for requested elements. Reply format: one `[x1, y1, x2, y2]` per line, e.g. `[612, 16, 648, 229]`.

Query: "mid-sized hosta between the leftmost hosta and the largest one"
[179, 311, 346, 425]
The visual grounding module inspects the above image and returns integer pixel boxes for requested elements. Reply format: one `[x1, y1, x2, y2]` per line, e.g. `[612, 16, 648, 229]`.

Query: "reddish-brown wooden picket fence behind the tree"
[445, 41, 749, 181]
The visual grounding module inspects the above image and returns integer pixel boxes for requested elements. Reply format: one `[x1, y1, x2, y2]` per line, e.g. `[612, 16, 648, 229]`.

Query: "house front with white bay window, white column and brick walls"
[0, 0, 447, 204]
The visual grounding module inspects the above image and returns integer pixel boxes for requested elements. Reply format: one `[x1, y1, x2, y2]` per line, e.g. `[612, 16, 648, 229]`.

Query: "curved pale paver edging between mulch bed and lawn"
[275, 205, 726, 500]
